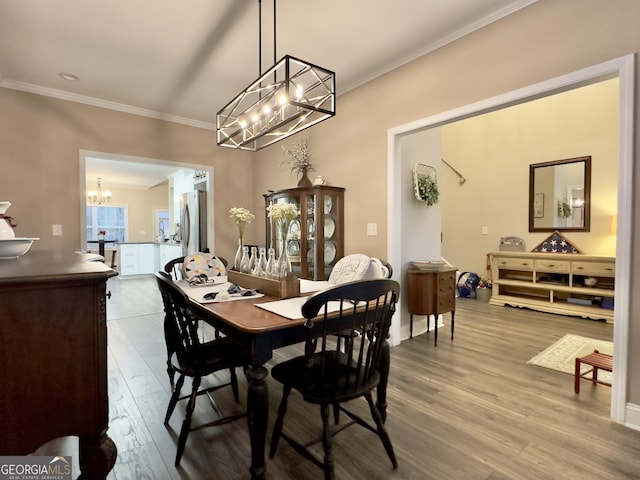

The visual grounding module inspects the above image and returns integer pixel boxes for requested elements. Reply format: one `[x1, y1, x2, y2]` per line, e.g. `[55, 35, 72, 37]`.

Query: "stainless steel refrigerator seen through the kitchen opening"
[180, 190, 208, 255]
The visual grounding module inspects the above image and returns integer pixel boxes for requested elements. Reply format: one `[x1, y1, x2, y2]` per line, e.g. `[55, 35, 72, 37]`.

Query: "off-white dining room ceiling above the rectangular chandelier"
[0, 0, 535, 187]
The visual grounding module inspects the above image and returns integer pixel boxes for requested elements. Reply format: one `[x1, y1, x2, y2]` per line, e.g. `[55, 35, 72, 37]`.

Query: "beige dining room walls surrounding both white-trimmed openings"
[0, 0, 640, 404]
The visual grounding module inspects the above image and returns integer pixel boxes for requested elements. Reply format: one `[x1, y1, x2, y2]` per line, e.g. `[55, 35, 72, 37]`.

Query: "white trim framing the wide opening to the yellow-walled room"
[387, 55, 635, 423]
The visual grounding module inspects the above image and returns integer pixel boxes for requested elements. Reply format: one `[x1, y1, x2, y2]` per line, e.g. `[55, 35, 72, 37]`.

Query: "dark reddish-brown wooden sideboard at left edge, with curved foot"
[0, 251, 117, 479]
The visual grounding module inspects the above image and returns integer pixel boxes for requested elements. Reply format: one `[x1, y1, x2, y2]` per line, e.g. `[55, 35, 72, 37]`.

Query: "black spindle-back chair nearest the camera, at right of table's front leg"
[269, 279, 400, 480]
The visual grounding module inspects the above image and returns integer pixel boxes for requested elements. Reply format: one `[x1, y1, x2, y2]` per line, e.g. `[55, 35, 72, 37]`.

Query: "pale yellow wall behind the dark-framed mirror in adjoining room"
[440, 79, 619, 275]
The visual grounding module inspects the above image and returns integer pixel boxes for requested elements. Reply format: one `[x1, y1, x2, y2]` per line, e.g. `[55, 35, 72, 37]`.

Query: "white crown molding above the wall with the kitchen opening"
[0, 80, 216, 130]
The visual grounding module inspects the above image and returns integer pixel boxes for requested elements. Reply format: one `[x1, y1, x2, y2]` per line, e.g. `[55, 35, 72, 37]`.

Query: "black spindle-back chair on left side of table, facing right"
[156, 272, 248, 467]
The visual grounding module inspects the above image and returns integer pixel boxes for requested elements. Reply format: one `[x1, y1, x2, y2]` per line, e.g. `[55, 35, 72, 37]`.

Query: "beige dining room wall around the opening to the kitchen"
[0, 88, 253, 257]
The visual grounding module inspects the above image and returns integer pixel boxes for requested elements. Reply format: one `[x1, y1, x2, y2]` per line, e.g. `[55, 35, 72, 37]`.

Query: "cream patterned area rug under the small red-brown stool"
[527, 335, 613, 382]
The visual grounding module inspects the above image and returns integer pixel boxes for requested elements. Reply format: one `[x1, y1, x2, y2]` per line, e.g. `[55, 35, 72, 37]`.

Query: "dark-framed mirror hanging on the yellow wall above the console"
[529, 157, 591, 232]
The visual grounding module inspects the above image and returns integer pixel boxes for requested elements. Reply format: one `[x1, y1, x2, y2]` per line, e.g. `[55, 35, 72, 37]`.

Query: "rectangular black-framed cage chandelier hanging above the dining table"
[216, 0, 336, 152]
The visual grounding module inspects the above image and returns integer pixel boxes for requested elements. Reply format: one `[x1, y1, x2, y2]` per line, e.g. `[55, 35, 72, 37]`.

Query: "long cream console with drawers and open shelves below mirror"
[490, 252, 616, 323]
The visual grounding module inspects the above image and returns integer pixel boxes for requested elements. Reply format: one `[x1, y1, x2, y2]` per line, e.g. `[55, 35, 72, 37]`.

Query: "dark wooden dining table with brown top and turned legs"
[183, 282, 390, 480]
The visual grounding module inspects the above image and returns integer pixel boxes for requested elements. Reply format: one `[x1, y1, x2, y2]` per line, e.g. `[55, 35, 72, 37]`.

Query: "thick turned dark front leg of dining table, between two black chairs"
[246, 365, 269, 480]
